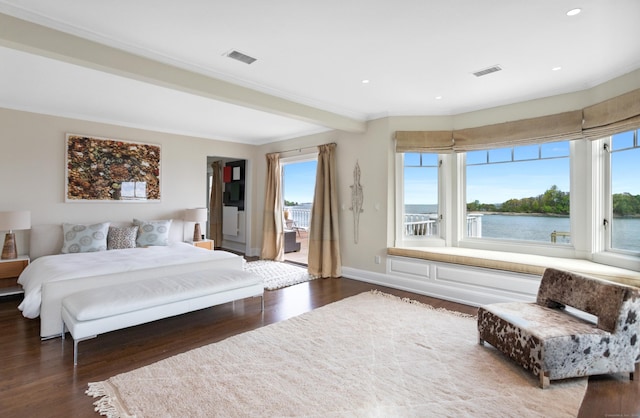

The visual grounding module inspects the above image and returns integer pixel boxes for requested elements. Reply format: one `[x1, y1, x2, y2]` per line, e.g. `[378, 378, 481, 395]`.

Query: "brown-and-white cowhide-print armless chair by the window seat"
[478, 268, 640, 388]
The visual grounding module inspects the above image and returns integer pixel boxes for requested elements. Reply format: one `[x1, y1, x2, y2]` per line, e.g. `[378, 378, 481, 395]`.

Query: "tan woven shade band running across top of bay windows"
[395, 89, 640, 153]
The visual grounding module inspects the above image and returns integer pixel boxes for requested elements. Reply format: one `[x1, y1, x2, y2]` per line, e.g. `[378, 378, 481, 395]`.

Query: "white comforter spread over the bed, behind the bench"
[18, 242, 239, 318]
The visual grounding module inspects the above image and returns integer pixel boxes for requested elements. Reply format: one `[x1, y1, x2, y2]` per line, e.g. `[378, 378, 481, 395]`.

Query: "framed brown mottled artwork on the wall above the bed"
[65, 134, 161, 202]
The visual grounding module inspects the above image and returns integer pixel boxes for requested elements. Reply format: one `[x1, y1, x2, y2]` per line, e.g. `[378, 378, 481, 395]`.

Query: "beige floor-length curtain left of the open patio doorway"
[260, 153, 284, 261]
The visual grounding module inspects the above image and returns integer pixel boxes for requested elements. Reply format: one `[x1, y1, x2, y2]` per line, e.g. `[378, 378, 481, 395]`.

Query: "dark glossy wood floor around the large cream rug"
[0, 279, 640, 418]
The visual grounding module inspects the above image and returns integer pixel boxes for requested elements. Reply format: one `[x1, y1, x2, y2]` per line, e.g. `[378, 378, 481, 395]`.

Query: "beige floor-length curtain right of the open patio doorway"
[309, 144, 342, 277]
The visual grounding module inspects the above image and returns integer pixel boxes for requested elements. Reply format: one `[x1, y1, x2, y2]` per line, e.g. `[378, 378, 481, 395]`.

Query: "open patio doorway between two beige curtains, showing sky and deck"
[281, 155, 318, 265]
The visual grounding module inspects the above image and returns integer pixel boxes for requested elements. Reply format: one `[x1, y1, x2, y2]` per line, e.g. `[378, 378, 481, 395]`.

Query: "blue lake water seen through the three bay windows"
[405, 205, 640, 251]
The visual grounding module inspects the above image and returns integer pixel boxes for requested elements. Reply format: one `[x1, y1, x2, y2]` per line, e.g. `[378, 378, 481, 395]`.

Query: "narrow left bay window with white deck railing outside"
[403, 153, 440, 238]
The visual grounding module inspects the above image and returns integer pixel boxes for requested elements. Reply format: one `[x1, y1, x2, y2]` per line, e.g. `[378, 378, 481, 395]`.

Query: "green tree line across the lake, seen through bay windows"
[467, 185, 640, 216]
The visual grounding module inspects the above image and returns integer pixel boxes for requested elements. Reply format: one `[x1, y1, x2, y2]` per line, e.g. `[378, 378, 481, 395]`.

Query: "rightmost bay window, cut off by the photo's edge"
[607, 130, 640, 253]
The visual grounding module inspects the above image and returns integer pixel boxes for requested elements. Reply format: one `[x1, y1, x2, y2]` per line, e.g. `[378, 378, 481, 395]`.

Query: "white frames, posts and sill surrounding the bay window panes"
[395, 134, 640, 270]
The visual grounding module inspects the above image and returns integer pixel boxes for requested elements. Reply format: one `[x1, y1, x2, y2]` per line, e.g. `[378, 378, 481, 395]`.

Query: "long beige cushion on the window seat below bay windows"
[387, 247, 640, 287]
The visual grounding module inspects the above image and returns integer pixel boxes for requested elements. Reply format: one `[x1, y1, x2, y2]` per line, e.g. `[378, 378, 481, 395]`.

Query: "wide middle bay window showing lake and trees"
[466, 141, 571, 244]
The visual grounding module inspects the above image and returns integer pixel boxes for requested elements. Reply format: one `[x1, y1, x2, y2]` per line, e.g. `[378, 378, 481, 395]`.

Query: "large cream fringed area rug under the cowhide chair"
[87, 291, 587, 418]
